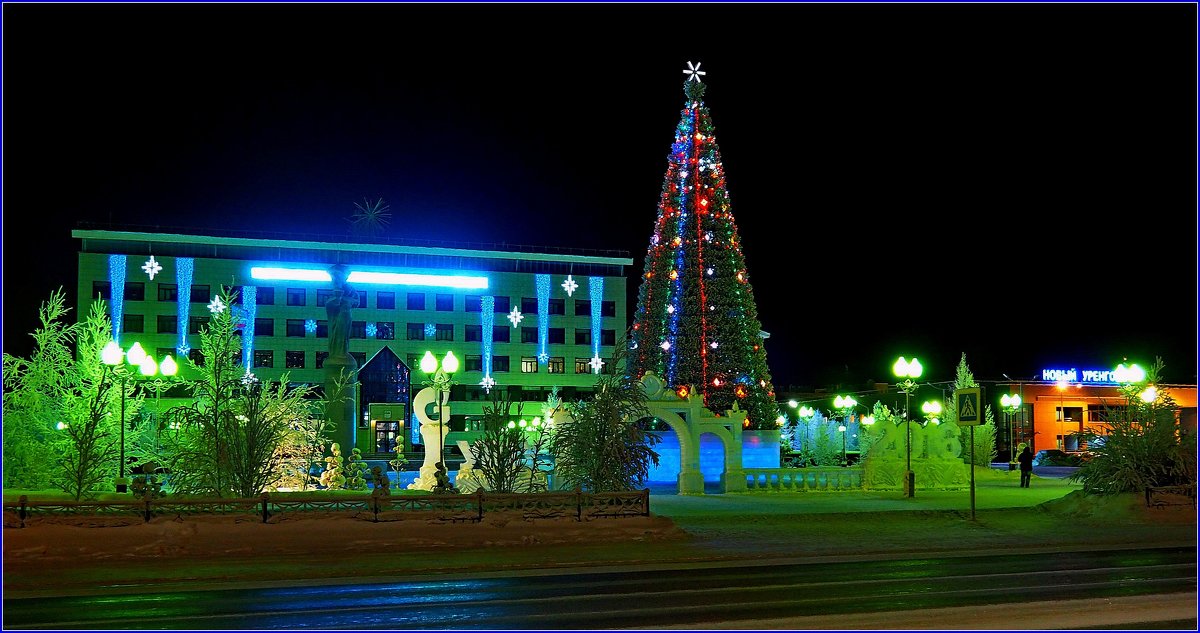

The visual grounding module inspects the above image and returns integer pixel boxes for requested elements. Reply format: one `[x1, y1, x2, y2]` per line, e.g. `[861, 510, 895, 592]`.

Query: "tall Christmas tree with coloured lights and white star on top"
[630, 62, 779, 428]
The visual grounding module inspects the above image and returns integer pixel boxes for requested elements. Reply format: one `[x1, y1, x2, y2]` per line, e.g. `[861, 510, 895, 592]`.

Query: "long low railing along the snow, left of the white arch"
[4, 488, 650, 528]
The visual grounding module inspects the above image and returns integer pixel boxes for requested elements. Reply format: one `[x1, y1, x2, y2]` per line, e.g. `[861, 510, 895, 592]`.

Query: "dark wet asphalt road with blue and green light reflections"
[4, 548, 1196, 629]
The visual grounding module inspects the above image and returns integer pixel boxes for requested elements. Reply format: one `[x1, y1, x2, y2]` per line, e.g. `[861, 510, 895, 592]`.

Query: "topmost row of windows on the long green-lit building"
[91, 282, 617, 317]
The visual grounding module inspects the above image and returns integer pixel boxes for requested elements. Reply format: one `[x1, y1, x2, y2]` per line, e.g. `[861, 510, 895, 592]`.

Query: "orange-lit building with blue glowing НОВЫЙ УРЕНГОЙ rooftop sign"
[992, 369, 1196, 453]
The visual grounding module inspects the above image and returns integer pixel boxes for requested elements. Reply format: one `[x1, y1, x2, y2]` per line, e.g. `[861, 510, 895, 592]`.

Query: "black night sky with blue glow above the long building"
[2, 4, 1196, 388]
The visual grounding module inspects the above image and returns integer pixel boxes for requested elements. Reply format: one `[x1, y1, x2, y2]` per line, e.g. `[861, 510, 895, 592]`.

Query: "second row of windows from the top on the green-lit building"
[121, 314, 617, 345]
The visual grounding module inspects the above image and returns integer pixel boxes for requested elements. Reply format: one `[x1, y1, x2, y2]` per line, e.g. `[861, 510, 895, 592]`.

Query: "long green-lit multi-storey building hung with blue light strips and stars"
[72, 229, 632, 458]
